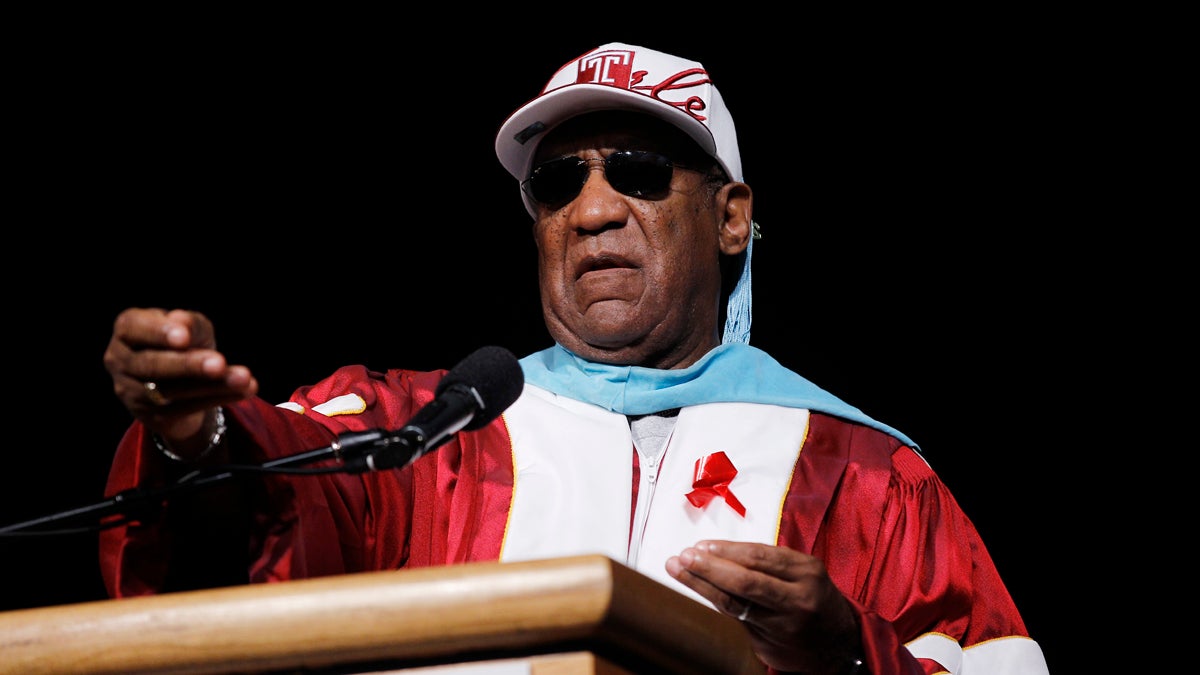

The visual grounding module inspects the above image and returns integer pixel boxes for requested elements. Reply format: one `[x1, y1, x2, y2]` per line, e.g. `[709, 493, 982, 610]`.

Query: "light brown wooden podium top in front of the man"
[0, 555, 766, 675]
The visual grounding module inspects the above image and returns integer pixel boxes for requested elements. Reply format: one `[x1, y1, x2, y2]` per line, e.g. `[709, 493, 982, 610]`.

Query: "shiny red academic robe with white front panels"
[101, 366, 1046, 675]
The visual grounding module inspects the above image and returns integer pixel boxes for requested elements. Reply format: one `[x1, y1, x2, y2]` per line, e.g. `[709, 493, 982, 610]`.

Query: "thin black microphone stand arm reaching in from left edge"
[0, 429, 396, 534]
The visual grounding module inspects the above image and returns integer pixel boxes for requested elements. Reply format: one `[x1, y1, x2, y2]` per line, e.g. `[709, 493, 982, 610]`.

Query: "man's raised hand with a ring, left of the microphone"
[104, 307, 258, 456]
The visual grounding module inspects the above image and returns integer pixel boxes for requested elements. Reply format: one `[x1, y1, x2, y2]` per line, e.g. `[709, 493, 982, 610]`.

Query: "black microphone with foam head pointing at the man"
[350, 347, 524, 471]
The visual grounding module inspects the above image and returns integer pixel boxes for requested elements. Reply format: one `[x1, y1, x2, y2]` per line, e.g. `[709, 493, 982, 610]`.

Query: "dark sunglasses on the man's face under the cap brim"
[521, 150, 696, 208]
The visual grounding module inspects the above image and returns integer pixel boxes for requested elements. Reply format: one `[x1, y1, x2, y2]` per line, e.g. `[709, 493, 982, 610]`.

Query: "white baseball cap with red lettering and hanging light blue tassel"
[496, 42, 757, 342]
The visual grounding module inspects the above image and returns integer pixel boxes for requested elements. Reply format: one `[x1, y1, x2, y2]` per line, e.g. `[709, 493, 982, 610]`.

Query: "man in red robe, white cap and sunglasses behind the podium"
[102, 43, 1046, 674]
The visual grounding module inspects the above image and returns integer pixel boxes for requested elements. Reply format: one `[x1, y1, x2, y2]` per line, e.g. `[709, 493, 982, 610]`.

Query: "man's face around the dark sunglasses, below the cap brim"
[533, 113, 722, 368]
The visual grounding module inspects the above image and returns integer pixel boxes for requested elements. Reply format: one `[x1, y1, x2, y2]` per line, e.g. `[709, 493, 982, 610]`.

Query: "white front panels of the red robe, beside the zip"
[500, 386, 809, 604]
